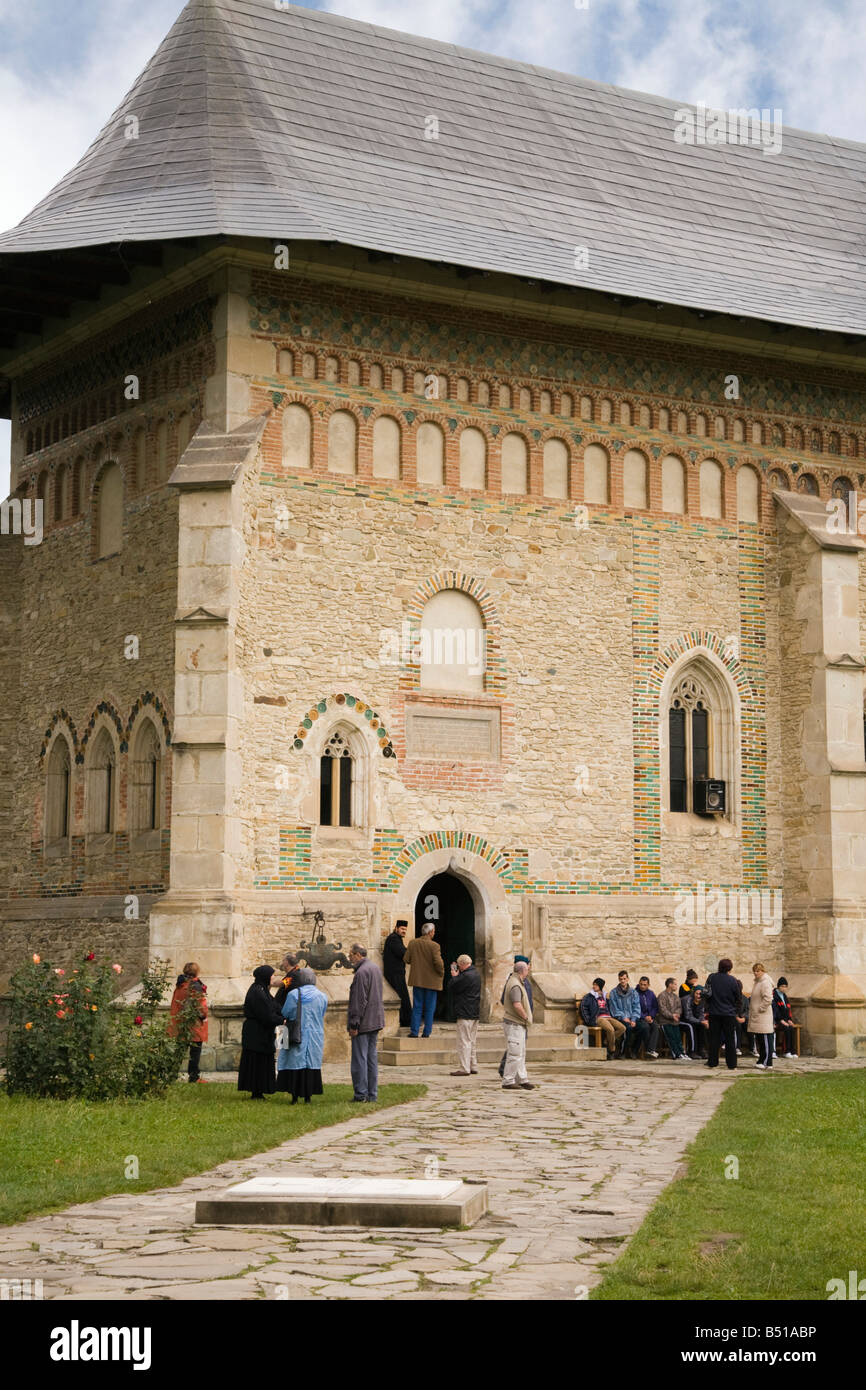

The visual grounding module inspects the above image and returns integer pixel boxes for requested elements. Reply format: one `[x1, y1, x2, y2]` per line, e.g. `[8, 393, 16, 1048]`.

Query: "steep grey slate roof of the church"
[0, 0, 866, 334]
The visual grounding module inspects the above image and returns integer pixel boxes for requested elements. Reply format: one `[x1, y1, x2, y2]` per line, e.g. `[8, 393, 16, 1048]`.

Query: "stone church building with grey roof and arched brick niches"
[0, 0, 866, 1066]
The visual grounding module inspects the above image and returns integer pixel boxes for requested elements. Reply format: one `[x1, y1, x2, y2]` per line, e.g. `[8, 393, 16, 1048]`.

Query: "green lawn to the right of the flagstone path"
[591, 1070, 866, 1300]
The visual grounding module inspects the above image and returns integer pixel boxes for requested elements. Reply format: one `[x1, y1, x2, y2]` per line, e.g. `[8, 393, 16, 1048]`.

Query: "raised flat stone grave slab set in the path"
[196, 1173, 488, 1227]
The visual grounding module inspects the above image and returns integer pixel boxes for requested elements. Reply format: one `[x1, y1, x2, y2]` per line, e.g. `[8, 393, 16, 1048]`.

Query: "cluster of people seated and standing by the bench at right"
[578, 956, 796, 1072]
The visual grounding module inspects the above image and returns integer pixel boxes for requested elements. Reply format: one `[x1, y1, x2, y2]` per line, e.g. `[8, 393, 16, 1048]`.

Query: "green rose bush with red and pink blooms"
[4, 952, 199, 1101]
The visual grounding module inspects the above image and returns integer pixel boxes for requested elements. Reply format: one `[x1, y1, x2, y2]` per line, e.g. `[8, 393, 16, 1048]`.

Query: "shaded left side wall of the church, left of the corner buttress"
[0, 279, 213, 974]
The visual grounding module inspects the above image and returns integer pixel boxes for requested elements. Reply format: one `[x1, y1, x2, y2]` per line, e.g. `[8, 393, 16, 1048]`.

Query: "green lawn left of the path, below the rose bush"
[0, 1081, 427, 1225]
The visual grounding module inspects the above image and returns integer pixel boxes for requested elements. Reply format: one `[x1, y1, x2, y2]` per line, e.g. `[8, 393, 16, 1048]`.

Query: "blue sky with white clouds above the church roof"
[0, 0, 866, 496]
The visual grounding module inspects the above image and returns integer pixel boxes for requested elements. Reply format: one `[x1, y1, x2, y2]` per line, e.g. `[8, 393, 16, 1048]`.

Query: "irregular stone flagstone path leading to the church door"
[0, 1062, 861, 1300]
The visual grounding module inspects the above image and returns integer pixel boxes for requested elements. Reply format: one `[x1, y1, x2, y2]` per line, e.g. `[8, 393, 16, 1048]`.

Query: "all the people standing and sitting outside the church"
[171, 920, 796, 1105]
